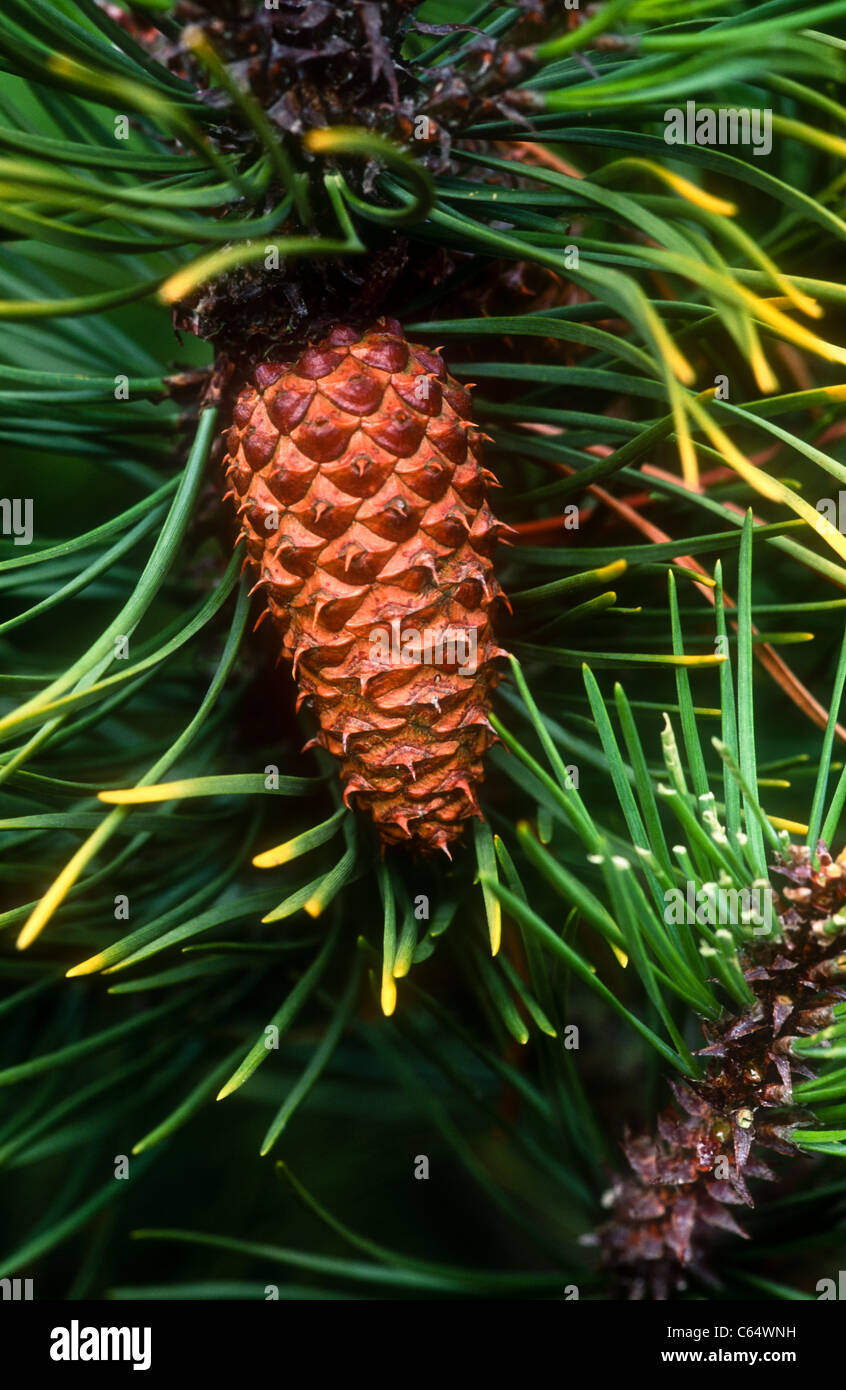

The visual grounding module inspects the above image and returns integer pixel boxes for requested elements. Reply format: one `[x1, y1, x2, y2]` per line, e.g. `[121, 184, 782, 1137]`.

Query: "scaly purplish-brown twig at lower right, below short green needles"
[585, 844, 846, 1300]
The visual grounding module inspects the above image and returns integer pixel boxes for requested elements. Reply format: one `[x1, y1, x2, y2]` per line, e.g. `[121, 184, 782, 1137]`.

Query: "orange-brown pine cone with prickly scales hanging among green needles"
[225, 318, 507, 853]
